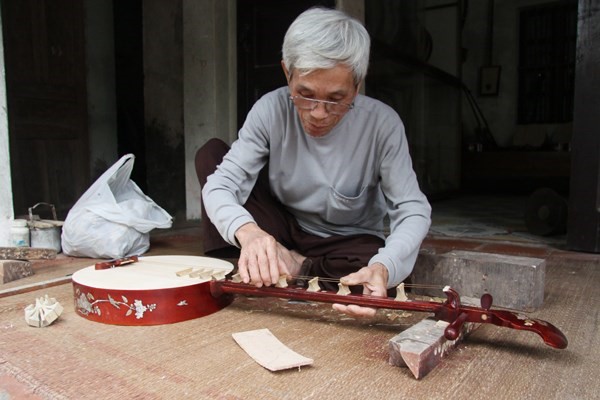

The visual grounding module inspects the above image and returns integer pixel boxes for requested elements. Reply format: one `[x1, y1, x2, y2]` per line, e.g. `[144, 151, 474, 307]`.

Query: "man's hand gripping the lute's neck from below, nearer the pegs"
[333, 263, 388, 317]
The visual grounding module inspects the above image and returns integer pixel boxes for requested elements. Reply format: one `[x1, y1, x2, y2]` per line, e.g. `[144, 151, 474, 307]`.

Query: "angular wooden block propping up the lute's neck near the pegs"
[389, 317, 480, 379]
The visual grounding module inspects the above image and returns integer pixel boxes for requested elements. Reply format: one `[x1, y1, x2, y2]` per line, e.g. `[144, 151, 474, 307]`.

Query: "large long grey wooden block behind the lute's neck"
[411, 250, 546, 312]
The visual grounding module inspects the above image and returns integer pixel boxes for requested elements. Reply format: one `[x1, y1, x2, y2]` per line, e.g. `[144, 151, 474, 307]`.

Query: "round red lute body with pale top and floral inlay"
[73, 256, 233, 325]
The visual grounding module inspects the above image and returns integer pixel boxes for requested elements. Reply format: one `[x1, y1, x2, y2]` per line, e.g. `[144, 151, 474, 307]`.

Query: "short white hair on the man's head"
[282, 7, 371, 84]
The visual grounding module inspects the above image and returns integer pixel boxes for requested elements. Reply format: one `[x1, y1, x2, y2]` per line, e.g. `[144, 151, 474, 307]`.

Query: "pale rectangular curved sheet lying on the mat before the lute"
[232, 329, 313, 371]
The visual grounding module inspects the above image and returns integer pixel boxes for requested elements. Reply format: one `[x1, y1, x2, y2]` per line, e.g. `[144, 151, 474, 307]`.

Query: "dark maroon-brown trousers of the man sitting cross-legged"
[195, 139, 385, 290]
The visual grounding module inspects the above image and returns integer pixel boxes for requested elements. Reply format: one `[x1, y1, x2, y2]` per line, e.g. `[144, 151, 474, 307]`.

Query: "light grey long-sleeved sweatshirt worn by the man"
[202, 87, 431, 288]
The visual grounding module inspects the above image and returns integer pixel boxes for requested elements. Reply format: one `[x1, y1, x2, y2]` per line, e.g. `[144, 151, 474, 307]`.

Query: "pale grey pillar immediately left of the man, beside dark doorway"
[183, 0, 237, 220]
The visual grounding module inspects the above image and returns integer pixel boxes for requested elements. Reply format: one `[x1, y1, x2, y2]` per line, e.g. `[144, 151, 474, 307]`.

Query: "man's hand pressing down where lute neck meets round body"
[235, 223, 303, 287]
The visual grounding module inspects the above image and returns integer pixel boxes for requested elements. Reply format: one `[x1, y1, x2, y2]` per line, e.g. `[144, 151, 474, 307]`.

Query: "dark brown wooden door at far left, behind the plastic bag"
[2, 0, 89, 218]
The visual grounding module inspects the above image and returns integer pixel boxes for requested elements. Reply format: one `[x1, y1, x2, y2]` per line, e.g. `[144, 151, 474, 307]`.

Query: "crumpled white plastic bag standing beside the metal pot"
[61, 154, 173, 259]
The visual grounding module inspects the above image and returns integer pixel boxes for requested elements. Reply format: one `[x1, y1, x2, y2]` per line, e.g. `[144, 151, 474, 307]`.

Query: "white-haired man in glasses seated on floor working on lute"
[196, 8, 431, 316]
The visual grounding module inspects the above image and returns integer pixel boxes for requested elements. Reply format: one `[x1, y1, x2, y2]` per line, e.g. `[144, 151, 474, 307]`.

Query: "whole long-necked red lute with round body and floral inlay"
[73, 256, 568, 349]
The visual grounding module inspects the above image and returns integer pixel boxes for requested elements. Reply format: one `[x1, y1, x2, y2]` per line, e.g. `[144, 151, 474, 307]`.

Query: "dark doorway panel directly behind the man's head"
[237, 0, 335, 127]
